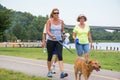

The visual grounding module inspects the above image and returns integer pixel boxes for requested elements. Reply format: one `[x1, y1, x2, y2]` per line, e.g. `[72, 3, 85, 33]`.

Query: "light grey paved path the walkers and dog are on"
[0, 55, 120, 80]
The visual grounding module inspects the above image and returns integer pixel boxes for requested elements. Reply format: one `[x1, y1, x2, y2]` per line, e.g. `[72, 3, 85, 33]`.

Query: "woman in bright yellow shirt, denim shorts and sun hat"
[73, 14, 92, 61]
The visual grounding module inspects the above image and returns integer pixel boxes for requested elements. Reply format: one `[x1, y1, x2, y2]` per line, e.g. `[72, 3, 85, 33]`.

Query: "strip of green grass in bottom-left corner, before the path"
[0, 69, 50, 80]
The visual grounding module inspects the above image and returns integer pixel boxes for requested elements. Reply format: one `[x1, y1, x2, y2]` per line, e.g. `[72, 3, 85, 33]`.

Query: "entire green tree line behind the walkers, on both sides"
[0, 4, 120, 42]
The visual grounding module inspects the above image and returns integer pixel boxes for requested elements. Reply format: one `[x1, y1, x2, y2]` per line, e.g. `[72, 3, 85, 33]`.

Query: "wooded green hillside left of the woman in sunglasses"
[0, 5, 48, 41]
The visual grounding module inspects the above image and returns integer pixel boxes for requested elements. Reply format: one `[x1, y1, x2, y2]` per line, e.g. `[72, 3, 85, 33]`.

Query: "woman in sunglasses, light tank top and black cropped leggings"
[46, 8, 68, 78]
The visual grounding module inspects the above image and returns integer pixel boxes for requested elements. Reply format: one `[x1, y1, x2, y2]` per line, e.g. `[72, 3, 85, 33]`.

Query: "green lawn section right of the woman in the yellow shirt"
[90, 51, 120, 71]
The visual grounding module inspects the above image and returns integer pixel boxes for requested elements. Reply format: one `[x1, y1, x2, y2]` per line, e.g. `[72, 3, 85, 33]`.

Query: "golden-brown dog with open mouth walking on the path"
[74, 57, 101, 80]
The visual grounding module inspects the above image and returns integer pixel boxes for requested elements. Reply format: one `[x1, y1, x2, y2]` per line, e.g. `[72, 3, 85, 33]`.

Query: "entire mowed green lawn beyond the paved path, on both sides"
[0, 48, 120, 72]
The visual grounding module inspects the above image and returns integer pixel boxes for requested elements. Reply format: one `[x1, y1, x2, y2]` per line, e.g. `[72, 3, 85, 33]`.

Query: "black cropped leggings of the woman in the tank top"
[47, 40, 63, 61]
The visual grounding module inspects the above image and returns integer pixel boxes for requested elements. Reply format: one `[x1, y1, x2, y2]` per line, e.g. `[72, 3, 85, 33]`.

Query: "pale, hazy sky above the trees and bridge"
[0, 0, 120, 27]
